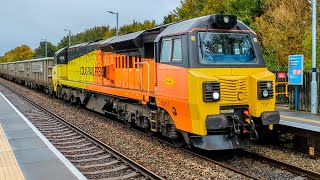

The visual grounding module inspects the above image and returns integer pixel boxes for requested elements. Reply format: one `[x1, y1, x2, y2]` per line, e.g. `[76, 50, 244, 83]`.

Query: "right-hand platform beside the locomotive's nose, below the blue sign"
[276, 106, 320, 132]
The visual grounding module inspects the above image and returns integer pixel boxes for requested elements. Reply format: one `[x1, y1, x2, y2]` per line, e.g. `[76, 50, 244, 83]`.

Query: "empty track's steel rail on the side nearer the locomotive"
[1, 83, 164, 180]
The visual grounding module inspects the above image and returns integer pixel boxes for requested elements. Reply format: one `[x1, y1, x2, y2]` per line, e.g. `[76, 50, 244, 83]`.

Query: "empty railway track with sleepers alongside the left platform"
[3, 84, 163, 180]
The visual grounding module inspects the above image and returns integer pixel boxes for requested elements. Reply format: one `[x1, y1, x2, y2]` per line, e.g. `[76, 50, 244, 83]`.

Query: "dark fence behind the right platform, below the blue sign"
[273, 72, 320, 112]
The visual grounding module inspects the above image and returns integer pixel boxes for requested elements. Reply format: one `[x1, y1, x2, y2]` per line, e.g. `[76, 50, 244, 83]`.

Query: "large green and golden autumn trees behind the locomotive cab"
[163, 0, 320, 71]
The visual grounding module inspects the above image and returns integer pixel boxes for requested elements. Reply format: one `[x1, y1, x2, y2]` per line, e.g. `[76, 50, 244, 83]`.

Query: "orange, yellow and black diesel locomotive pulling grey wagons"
[1, 14, 280, 150]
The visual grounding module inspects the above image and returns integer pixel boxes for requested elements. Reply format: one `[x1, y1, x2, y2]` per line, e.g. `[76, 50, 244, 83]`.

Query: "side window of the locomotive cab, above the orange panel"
[160, 38, 182, 63]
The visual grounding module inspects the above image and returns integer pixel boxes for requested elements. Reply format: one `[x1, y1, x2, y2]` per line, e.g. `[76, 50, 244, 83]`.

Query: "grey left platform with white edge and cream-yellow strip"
[0, 92, 86, 180]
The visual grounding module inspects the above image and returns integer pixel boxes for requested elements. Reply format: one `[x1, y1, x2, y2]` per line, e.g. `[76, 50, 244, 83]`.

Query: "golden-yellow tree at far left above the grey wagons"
[0, 45, 33, 62]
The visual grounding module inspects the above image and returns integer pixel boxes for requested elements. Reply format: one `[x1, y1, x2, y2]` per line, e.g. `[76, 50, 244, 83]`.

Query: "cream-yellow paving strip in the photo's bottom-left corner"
[0, 125, 25, 180]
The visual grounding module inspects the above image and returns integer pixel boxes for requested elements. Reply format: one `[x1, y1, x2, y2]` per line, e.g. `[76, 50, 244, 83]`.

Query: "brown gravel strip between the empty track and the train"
[0, 79, 246, 179]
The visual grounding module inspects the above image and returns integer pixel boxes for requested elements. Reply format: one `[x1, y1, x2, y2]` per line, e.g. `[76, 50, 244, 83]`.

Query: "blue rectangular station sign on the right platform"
[288, 55, 303, 85]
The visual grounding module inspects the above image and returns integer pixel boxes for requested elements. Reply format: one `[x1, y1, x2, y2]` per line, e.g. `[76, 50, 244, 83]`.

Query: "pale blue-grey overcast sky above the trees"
[0, 0, 180, 56]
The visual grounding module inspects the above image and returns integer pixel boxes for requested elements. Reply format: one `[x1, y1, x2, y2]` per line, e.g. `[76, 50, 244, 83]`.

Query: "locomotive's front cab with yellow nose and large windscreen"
[154, 15, 280, 150]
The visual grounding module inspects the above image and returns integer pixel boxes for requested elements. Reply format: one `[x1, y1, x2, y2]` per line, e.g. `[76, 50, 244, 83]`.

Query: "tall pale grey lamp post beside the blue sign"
[311, 0, 318, 114]
